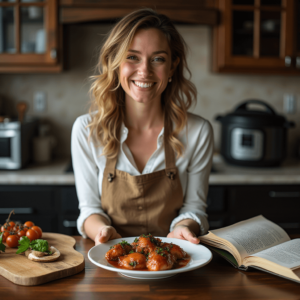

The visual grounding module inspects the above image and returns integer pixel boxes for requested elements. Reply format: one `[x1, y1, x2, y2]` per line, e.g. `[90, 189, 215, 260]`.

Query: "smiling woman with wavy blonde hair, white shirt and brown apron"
[72, 9, 213, 245]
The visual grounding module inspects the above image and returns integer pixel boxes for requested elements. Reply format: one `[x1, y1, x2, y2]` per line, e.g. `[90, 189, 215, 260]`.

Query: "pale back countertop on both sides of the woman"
[0, 155, 300, 185]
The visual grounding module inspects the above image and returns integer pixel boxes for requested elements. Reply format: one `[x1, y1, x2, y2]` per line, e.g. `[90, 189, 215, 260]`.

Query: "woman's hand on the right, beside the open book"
[167, 219, 200, 244]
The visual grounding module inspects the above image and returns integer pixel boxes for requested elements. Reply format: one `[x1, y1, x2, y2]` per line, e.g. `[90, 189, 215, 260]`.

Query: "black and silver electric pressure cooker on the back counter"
[216, 99, 295, 167]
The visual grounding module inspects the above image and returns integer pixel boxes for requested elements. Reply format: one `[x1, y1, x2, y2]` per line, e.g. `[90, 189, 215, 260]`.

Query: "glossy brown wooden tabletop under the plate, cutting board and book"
[0, 235, 300, 300]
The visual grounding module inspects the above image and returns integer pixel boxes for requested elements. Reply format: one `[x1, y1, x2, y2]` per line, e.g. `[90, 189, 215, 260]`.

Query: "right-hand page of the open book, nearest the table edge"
[251, 239, 300, 269]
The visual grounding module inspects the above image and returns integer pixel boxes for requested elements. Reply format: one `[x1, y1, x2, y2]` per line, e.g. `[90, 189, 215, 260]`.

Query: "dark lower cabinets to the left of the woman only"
[0, 185, 79, 235]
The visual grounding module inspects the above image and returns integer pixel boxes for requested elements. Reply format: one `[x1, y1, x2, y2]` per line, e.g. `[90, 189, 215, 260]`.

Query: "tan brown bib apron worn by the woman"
[101, 117, 183, 237]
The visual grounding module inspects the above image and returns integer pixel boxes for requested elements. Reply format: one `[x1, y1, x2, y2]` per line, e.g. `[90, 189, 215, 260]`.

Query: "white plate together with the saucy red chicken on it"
[88, 234, 212, 279]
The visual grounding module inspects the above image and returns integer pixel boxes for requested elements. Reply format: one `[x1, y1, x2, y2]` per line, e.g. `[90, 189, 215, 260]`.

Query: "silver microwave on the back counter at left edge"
[0, 117, 38, 170]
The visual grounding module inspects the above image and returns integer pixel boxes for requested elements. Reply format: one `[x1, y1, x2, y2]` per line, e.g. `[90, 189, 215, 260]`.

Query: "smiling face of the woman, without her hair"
[119, 28, 177, 103]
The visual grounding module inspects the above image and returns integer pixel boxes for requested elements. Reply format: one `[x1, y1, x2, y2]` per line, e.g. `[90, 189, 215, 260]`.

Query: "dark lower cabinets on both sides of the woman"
[0, 185, 300, 235]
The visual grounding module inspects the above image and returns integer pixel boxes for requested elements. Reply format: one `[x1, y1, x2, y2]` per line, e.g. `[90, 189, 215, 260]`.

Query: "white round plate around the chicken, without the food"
[88, 237, 212, 279]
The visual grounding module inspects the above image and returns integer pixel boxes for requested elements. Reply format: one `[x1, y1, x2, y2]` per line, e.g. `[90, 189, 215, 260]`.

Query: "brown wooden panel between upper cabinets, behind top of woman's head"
[59, 0, 218, 25]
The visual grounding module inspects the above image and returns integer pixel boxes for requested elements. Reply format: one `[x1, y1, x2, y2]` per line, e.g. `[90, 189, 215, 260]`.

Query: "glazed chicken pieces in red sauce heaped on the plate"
[105, 234, 188, 271]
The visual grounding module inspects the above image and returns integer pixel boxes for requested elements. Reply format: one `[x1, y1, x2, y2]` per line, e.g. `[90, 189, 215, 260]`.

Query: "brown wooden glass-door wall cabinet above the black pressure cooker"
[213, 0, 300, 75]
